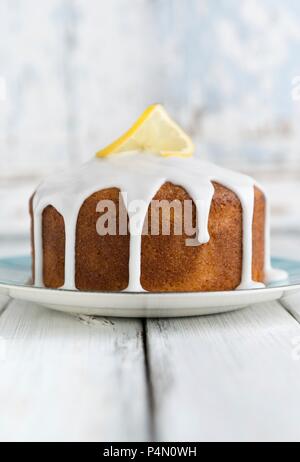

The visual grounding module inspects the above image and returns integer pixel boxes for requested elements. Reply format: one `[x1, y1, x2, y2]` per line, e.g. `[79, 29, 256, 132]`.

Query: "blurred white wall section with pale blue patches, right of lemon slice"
[153, 0, 300, 169]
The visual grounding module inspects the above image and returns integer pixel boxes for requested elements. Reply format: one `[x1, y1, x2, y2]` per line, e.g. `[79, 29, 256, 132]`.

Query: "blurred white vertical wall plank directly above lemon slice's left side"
[66, 0, 164, 161]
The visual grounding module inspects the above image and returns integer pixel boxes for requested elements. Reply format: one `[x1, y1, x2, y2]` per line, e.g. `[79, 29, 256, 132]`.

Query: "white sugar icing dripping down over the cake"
[33, 152, 286, 292]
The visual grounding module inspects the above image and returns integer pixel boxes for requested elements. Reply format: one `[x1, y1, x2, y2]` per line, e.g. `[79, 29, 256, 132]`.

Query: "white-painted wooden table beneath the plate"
[0, 235, 300, 441]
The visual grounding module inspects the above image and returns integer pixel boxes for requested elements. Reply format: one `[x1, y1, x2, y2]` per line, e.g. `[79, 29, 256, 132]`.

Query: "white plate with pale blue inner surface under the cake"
[0, 257, 300, 318]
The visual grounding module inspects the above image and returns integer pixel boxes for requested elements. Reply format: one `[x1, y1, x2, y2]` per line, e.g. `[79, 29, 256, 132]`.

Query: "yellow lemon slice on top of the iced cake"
[96, 104, 195, 157]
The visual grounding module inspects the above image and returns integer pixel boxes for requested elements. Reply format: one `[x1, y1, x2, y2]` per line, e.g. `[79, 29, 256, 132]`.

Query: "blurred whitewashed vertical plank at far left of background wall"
[0, 0, 69, 175]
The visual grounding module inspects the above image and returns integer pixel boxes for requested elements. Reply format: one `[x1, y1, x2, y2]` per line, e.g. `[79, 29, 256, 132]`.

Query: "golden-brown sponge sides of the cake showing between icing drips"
[29, 183, 265, 292]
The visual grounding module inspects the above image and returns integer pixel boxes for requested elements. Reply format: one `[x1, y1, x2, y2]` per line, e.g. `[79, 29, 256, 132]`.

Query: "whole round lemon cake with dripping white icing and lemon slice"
[30, 104, 284, 292]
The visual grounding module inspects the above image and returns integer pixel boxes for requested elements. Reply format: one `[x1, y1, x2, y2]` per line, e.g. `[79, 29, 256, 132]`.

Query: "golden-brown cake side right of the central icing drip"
[141, 183, 265, 292]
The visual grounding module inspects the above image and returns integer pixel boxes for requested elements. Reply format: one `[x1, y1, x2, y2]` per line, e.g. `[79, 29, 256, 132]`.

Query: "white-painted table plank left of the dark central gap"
[0, 302, 149, 441]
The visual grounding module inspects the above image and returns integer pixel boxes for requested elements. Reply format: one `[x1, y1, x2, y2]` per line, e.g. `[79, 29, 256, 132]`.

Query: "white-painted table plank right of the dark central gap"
[148, 303, 300, 441]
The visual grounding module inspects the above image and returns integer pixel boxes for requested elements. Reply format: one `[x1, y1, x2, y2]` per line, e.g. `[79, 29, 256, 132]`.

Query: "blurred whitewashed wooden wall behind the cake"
[0, 0, 300, 253]
